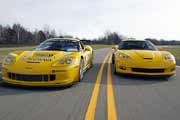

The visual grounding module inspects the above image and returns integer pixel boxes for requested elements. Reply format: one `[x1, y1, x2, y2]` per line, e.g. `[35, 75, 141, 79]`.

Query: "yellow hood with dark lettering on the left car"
[3, 51, 80, 74]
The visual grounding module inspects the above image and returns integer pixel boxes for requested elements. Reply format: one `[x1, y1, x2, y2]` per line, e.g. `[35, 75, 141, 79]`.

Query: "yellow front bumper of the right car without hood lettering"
[115, 61, 176, 76]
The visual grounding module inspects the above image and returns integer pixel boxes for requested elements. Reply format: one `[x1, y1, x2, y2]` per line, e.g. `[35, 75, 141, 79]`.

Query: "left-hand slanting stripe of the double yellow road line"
[85, 54, 109, 120]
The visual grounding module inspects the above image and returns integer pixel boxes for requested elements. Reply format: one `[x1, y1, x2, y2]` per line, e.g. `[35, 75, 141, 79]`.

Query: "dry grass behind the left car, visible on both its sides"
[0, 45, 111, 63]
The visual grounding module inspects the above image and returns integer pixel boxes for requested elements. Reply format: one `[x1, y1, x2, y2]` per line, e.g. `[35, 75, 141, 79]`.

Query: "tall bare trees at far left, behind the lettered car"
[0, 24, 59, 44]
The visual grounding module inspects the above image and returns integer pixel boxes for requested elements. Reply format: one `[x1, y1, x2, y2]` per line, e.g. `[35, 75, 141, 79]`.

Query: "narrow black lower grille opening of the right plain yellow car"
[132, 68, 164, 73]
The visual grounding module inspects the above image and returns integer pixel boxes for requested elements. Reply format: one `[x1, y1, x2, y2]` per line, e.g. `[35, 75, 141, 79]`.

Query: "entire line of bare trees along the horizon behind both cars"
[0, 24, 180, 45]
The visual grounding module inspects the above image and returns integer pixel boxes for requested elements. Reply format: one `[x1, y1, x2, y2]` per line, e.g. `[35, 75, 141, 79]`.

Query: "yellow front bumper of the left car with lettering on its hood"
[2, 66, 79, 86]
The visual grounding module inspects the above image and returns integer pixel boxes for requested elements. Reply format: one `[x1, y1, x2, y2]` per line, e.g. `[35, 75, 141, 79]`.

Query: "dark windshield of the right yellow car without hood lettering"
[118, 41, 156, 50]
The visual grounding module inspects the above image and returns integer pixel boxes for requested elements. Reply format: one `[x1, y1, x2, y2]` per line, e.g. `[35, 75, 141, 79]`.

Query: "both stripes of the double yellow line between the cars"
[85, 53, 117, 120]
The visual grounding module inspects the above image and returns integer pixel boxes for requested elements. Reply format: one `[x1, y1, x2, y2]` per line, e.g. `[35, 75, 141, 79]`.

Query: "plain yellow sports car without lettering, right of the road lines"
[112, 40, 176, 76]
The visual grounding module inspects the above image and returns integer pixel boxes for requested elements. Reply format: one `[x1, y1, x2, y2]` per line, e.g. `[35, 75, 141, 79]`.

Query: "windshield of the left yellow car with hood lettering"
[35, 40, 79, 52]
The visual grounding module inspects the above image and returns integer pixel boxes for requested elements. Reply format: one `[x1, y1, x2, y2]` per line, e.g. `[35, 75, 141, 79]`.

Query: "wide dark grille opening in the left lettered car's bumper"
[8, 73, 56, 82]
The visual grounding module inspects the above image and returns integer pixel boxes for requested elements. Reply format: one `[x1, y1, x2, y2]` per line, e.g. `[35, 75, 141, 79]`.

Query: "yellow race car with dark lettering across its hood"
[2, 38, 93, 86]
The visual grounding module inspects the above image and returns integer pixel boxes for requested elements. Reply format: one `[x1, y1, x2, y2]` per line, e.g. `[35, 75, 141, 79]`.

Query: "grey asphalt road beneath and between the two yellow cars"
[0, 49, 180, 120]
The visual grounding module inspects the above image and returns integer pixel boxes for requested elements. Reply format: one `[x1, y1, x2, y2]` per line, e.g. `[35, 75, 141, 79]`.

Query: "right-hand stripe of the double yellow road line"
[107, 54, 117, 120]
